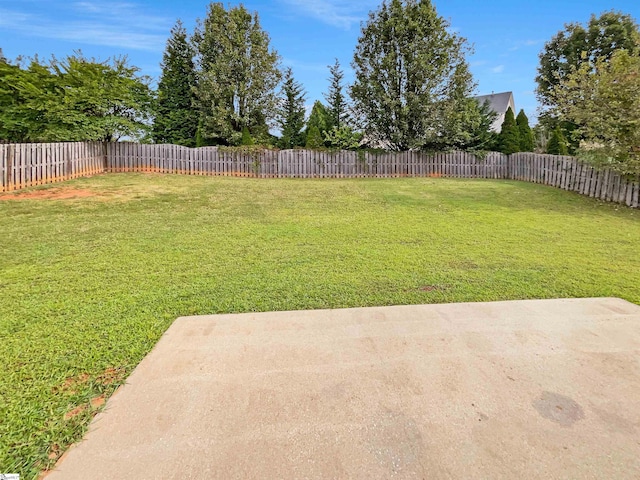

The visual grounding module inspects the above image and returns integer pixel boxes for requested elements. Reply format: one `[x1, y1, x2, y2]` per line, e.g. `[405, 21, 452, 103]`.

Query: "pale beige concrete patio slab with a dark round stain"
[47, 298, 640, 480]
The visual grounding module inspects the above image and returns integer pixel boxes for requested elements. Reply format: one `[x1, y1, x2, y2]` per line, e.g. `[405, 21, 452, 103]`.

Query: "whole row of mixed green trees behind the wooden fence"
[0, 0, 640, 173]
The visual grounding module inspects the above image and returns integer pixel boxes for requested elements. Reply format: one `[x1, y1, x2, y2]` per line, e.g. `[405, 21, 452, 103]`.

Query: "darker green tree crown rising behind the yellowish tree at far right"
[536, 11, 640, 107]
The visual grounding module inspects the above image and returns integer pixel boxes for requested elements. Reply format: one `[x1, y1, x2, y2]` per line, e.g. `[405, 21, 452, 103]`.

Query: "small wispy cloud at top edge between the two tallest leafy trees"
[280, 0, 376, 30]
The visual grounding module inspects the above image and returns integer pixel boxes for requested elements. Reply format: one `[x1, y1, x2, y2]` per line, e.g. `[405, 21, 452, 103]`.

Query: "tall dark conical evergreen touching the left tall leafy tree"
[152, 20, 198, 147]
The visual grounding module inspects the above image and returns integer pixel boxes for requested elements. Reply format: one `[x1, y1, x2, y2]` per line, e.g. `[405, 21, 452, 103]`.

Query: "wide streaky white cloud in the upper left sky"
[0, 1, 173, 51]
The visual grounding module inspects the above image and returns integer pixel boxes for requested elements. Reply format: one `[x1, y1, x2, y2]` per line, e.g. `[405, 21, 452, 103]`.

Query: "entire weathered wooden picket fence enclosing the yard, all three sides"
[0, 143, 640, 208]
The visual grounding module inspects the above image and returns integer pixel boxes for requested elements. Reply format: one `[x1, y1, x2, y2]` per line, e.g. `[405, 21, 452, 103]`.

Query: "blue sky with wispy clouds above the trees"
[0, 0, 640, 124]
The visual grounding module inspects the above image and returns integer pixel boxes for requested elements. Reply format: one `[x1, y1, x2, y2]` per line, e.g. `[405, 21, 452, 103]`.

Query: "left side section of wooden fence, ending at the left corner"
[0, 142, 106, 192]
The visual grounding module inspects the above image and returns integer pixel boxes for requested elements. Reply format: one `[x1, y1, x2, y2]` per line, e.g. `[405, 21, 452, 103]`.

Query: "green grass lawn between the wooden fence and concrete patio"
[0, 174, 640, 479]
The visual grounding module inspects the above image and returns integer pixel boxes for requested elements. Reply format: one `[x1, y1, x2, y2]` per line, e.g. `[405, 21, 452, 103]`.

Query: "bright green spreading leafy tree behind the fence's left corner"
[0, 53, 153, 142]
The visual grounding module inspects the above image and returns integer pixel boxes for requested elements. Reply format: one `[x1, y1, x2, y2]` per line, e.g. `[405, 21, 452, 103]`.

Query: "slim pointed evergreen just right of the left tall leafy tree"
[276, 68, 305, 148]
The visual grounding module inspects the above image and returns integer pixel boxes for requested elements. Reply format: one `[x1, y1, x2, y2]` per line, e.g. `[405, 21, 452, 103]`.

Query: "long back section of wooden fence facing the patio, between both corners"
[107, 143, 508, 179]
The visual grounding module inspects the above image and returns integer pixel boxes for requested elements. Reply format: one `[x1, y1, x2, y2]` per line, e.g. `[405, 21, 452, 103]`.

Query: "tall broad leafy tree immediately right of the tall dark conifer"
[193, 2, 281, 145]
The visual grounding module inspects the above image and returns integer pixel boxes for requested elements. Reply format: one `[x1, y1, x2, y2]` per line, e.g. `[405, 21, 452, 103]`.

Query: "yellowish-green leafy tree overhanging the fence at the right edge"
[554, 50, 640, 175]
